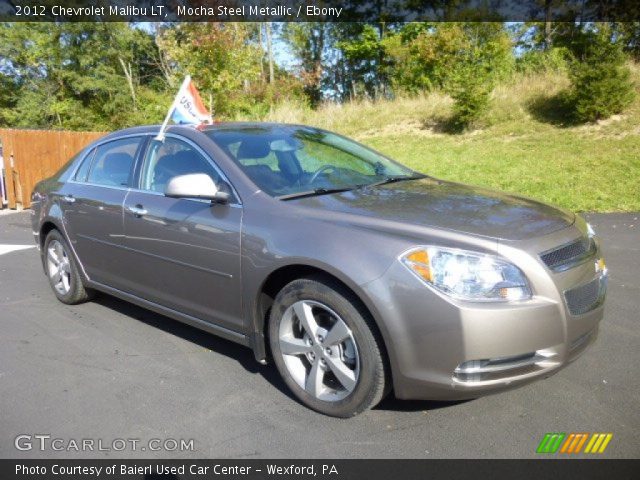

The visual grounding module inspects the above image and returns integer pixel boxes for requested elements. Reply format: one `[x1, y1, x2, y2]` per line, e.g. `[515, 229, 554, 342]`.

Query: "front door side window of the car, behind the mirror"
[140, 137, 220, 193]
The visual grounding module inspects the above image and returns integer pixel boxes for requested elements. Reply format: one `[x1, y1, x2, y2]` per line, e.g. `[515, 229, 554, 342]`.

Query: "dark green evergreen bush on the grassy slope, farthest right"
[568, 28, 635, 122]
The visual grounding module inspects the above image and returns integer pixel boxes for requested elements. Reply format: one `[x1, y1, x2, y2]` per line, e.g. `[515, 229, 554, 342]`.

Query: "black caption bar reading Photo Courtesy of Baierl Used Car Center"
[0, 459, 640, 480]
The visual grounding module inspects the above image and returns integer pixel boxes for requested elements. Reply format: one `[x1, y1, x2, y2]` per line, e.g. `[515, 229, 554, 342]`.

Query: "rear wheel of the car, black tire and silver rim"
[44, 230, 93, 305]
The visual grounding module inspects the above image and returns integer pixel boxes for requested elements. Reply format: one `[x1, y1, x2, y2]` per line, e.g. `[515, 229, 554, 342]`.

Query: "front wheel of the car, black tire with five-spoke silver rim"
[268, 277, 390, 418]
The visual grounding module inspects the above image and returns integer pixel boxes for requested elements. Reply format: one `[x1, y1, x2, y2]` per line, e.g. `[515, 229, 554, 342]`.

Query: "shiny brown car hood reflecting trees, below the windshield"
[289, 178, 575, 240]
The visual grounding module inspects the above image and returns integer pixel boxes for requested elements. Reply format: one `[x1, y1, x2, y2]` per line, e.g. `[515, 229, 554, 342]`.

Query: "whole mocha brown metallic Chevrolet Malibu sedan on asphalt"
[32, 123, 607, 417]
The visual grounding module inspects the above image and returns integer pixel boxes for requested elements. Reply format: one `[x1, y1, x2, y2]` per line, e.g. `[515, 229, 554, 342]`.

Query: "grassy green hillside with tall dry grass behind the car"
[251, 65, 640, 212]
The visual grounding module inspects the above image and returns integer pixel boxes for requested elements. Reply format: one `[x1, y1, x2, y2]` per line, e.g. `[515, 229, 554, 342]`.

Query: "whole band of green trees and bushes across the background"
[0, 20, 640, 130]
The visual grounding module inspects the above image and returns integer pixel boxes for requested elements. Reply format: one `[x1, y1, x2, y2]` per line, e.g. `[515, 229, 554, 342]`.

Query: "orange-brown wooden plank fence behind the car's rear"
[0, 128, 104, 208]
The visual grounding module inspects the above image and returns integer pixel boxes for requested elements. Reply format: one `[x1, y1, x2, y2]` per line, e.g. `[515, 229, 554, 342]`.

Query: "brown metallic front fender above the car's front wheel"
[242, 193, 504, 366]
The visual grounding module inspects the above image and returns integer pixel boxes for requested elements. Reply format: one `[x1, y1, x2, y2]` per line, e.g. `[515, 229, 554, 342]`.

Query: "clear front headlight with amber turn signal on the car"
[400, 247, 531, 301]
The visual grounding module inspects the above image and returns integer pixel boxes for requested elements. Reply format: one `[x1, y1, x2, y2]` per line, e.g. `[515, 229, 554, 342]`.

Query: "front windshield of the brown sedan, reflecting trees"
[204, 125, 417, 198]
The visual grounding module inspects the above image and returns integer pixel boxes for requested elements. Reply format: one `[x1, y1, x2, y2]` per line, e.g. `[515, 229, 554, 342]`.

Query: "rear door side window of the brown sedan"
[87, 137, 140, 187]
